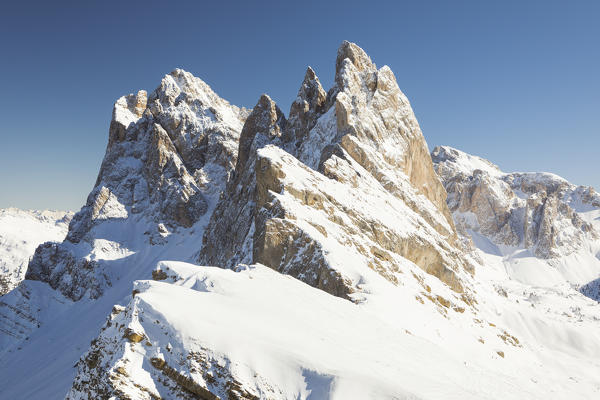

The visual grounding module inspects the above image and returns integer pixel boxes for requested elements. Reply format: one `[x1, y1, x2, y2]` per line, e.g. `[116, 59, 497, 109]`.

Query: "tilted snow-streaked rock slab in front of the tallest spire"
[253, 146, 462, 297]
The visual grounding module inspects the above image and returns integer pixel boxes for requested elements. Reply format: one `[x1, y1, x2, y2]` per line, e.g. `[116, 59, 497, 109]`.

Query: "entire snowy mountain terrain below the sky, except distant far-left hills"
[0, 42, 600, 399]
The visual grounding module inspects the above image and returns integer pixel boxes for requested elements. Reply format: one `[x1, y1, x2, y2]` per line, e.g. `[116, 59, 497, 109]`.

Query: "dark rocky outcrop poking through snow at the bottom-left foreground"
[65, 277, 268, 400]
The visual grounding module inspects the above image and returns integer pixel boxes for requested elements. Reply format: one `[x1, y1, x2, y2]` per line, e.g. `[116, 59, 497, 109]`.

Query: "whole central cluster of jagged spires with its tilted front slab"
[198, 42, 469, 297]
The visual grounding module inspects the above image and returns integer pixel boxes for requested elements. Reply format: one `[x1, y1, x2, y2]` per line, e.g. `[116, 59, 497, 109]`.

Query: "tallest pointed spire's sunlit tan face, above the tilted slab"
[321, 42, 454, 236]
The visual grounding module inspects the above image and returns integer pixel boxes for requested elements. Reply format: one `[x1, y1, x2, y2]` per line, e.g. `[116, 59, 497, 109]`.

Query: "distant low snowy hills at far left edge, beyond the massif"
[0, 208, 73, 295]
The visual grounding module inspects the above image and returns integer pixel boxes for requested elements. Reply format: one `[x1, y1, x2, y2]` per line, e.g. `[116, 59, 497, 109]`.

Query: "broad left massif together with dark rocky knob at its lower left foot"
[27, 69, 248, 300]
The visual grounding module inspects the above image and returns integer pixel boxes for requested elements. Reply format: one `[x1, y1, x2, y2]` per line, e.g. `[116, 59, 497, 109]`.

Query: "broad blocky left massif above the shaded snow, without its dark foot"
[68, 70, 247, 242]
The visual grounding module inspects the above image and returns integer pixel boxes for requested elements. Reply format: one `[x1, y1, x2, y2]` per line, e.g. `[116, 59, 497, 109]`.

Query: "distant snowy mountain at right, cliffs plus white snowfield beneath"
[431, 147, 600, 286]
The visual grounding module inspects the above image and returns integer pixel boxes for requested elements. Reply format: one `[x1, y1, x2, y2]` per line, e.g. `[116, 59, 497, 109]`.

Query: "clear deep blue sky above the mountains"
[0, 0, 600, 210]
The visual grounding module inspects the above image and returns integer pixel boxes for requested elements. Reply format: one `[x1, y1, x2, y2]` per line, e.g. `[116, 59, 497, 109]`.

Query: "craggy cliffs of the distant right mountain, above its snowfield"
[431, 147, 600, 259]
